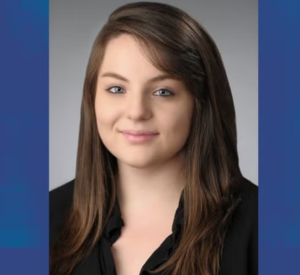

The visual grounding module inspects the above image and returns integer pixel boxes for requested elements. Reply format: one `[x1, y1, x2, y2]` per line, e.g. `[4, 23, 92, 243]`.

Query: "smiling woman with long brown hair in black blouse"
[50, 2, 258, 275]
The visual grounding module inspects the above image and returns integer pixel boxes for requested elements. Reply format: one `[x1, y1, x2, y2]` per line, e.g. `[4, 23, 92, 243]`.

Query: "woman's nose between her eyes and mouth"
[126, 93, 152, 120]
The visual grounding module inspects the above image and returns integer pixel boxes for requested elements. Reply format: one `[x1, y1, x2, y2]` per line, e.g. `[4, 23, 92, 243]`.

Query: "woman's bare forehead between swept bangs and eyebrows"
[100, 34, 166, 79]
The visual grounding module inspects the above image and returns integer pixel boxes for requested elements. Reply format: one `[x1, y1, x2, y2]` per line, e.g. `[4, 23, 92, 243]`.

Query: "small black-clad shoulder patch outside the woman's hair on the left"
[49, 179, 75, 249]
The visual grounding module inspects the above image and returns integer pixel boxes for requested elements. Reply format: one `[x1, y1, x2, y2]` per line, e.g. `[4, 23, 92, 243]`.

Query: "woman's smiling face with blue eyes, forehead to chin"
[95, 34, 193, 168]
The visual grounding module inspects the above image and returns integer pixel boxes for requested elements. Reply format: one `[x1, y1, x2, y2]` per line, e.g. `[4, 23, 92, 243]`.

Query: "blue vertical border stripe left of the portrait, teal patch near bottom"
[0, 0, 49, 275]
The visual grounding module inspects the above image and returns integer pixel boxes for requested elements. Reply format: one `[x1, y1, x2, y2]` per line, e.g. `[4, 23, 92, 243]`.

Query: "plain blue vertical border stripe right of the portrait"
[259, 0, 300, 275]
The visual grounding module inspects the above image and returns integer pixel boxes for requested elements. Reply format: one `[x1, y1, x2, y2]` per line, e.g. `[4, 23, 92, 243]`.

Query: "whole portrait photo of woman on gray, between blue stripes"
[49, 0, 258, 275]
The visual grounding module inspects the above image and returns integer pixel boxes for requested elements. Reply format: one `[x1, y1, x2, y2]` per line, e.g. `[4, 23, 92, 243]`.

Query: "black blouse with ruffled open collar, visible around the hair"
[50, 179, 258, 275]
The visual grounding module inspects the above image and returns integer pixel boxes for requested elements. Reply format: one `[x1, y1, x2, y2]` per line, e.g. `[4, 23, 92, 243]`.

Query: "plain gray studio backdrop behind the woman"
[49, 0, 258, 190]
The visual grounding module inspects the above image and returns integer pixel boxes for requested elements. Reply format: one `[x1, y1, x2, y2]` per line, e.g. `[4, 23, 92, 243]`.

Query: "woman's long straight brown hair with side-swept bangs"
[50, 2, 242, 275]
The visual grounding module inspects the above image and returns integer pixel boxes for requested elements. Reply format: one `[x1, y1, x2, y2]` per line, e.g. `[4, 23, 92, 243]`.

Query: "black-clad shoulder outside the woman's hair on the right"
[221, 178, 258, 275]
